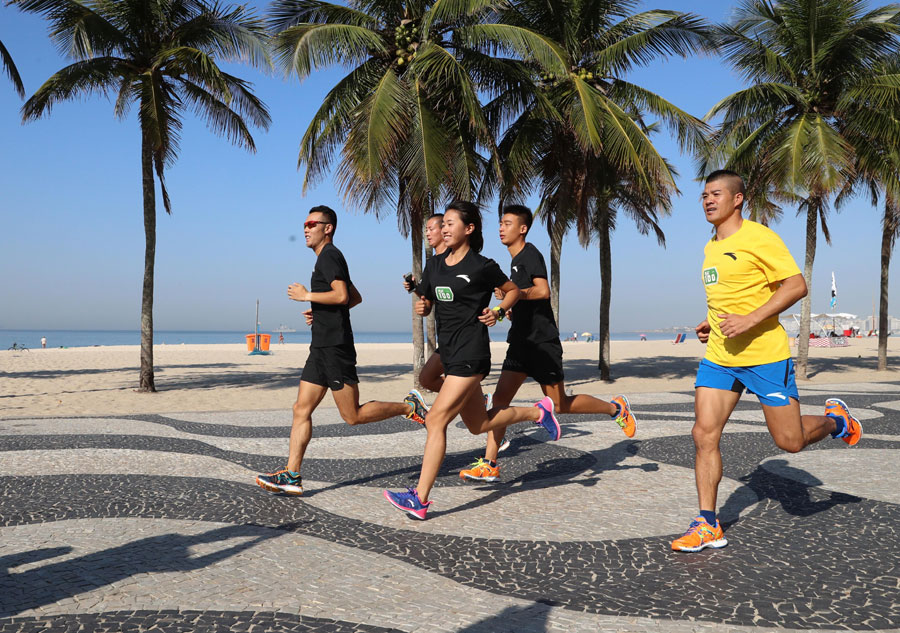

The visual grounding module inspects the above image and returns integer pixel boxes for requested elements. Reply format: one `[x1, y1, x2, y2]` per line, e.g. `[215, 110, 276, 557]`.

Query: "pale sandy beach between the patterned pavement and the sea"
[0, 338, 900, 418]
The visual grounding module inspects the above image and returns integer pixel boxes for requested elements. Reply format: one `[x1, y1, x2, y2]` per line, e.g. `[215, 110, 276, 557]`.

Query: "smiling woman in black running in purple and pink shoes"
[384, 202, 560, 519]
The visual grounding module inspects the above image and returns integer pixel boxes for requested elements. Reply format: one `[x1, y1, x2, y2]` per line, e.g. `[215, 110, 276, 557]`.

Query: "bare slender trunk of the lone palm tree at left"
[138, 124, 156, 392]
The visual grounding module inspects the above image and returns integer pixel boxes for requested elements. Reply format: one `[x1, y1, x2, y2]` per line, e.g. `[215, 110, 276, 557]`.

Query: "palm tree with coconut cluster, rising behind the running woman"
[270, 0, 560, 380]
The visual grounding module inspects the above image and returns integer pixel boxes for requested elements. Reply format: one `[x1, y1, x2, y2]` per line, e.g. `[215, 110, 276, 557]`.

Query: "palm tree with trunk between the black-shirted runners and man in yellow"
[487, 0, 710, 379]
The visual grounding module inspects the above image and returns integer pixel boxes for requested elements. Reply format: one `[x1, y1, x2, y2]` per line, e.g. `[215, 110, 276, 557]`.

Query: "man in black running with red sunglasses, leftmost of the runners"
[256, 206, 428, 495]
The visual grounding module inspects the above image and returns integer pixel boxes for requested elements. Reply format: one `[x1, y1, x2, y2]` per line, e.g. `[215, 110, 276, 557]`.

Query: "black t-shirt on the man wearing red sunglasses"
[309, 244, 353, 347]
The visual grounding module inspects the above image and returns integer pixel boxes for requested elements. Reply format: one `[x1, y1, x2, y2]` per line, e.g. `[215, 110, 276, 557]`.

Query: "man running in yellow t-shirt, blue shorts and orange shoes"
[672, 170, 862, 552]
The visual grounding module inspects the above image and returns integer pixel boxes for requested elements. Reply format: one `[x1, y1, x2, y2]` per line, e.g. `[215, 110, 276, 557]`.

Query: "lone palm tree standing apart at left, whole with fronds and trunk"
[10, 0, 270, 392]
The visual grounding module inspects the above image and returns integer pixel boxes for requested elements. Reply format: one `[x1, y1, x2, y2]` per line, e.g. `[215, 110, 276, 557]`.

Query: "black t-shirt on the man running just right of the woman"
[506, 242, 559, 343]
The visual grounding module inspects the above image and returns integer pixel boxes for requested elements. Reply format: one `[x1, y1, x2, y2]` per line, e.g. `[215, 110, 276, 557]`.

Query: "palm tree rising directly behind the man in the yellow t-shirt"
[701, 0, 900, 378]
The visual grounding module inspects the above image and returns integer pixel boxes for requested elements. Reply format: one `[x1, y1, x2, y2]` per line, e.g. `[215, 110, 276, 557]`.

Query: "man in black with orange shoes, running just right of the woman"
[459, 204, 636, 481]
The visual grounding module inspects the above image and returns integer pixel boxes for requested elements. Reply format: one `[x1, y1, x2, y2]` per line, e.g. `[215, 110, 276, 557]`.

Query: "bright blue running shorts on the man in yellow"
[694, 358, 800, 407]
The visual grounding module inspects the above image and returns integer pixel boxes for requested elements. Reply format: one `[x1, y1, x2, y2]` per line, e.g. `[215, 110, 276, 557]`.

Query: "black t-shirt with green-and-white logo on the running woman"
[417, 250, 509, 366]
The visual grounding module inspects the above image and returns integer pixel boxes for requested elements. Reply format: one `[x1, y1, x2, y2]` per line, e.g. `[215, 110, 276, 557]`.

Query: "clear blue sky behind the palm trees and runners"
[0, 0, 888, 332]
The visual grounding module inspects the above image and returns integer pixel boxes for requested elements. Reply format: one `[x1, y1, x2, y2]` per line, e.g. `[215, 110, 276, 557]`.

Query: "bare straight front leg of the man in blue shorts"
[691, 387, 741, 512]
